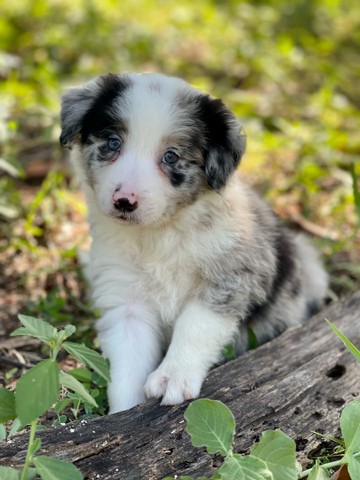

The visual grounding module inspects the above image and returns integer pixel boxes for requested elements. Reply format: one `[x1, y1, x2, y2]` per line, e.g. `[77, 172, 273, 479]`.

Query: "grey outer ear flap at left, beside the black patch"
[60, 85, 96, 148]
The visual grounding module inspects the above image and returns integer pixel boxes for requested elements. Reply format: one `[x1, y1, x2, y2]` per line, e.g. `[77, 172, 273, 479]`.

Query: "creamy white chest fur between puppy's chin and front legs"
[87, 215, 198, 324]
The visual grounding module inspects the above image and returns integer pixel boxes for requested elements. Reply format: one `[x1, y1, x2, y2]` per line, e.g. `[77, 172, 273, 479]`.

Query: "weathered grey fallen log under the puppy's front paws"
[0, 292, 360, 480]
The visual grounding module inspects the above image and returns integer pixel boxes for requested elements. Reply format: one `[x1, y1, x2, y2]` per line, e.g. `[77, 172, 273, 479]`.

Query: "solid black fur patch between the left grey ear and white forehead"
[80, 74, 129, 143]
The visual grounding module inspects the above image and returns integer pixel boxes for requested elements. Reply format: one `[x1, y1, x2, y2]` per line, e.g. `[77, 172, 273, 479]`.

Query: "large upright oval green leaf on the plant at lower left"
[15, 360, 59, 425]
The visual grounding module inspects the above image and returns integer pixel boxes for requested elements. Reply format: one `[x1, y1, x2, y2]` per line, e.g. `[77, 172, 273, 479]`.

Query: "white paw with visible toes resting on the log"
[144, 364, 203, 405]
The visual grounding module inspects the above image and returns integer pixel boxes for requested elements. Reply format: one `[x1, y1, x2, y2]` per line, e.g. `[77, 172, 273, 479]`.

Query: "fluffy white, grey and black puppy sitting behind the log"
[60, 74, 327, 412]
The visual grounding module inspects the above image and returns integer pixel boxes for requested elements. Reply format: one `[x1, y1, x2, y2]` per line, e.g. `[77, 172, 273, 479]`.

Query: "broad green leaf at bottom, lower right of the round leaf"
[250, 430, 297, 480]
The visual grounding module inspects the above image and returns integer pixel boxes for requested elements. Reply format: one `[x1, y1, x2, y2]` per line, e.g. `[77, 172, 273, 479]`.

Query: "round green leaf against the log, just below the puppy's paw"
[184, 399, 235, 456]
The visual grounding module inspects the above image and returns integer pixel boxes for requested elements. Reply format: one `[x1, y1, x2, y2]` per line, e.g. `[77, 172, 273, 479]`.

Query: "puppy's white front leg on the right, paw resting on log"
[145, 302, 237, 405]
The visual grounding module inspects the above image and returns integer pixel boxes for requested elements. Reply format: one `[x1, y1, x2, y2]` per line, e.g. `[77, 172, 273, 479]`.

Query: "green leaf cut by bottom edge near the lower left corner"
[33, 455, 83, 480]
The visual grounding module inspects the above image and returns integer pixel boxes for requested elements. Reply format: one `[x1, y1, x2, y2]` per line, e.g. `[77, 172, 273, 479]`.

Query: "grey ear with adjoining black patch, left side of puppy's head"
[60, 74, 129, 147]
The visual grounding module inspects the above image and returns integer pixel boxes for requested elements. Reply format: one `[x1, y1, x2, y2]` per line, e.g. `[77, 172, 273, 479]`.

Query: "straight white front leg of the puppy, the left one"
[96, 305, 161, 413]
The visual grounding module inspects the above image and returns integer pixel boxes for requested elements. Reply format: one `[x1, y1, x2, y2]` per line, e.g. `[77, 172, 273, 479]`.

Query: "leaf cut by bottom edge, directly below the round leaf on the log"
[219, 454, 273, 480]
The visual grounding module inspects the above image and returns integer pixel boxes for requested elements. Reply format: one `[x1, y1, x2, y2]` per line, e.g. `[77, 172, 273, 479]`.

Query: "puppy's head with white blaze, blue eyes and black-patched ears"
[60, 74, 245, 224]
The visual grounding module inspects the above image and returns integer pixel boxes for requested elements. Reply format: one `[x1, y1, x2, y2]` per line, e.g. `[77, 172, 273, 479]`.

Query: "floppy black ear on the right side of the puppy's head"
[197, 95, 246, 190]
